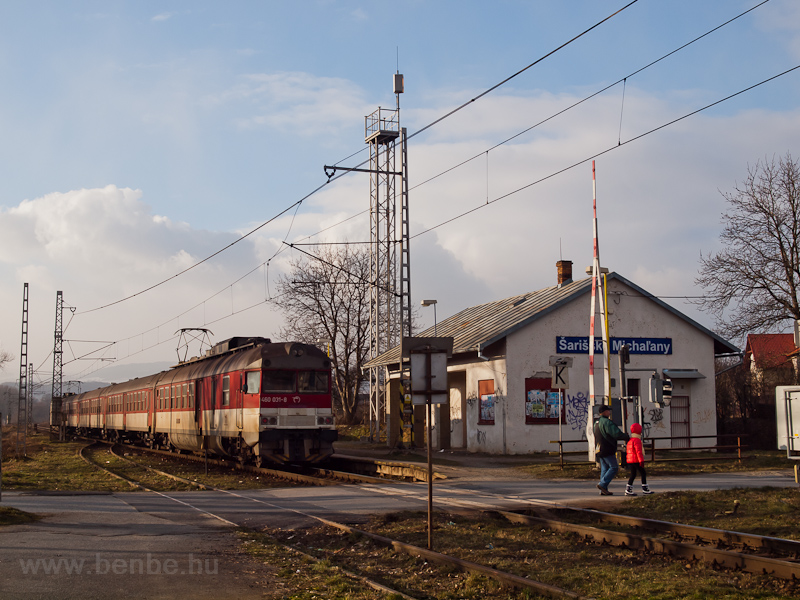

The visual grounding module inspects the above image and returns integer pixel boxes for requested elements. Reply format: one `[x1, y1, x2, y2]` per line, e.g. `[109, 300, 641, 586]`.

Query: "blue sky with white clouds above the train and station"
[0, 0, 800, 390]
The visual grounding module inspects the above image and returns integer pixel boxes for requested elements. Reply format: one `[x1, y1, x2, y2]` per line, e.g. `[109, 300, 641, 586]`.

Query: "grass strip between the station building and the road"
[517, 450, 795, 479]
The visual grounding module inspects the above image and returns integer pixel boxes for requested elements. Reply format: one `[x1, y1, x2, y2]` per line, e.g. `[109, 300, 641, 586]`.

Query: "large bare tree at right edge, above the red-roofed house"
[695, 153, 800, 339]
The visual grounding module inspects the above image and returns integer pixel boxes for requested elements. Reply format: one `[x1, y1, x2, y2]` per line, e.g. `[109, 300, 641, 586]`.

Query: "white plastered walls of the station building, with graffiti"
[444, 279, 716, 454]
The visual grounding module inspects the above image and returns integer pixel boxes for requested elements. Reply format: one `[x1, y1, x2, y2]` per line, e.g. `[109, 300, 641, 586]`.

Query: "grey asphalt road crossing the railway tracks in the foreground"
[0, 471, 797, 600]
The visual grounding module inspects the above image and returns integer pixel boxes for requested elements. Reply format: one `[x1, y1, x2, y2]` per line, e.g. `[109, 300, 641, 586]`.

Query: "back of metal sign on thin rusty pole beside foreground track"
[402, 337, 453, 550]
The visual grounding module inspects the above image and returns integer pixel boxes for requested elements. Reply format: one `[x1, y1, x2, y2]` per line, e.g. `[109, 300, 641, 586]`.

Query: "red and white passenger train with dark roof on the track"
[54, 337, 337, 466]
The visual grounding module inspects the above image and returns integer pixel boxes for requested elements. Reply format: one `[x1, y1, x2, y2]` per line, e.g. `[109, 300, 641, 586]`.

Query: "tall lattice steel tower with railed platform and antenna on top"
[365, 73, 411, 441]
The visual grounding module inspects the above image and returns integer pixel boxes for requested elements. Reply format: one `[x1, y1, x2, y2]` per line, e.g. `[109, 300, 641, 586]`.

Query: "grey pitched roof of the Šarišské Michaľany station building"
[365, 273, 738, 367]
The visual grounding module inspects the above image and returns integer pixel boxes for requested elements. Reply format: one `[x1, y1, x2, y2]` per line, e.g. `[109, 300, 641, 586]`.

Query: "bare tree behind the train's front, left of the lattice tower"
[275, 245, 370, 424]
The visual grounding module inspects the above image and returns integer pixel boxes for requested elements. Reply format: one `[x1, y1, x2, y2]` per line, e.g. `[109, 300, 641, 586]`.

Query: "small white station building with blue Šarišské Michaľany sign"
[369, 261, 739, 454]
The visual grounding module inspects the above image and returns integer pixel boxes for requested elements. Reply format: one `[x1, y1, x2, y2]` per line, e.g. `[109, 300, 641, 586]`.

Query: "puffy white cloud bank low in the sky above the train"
[0, 185, 284, 376]
